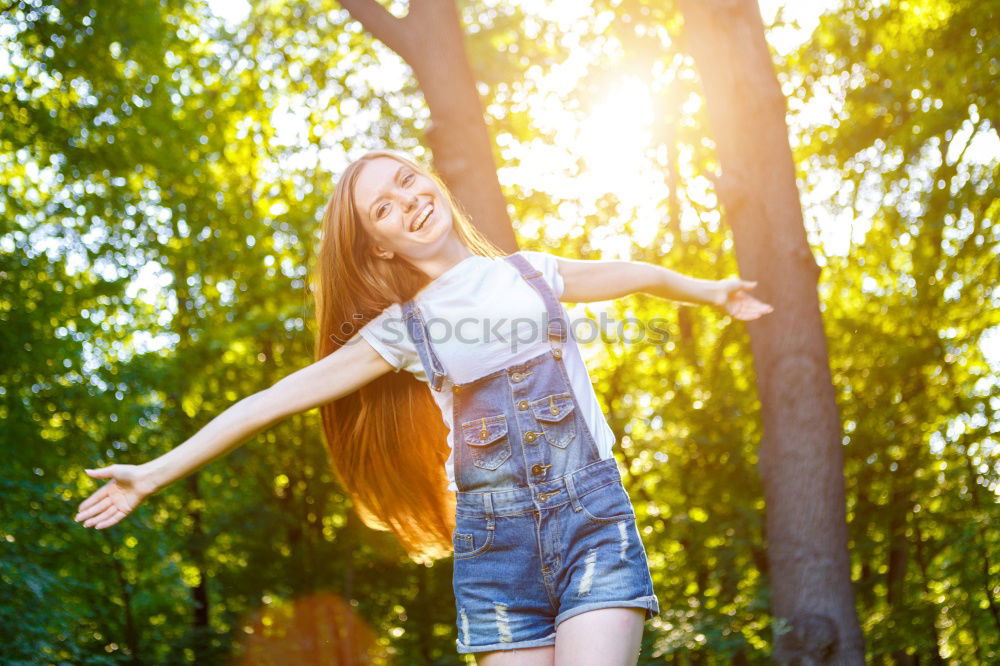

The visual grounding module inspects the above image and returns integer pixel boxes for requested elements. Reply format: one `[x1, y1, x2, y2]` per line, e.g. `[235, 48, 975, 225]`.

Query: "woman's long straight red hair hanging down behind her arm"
[313, 151, 504, 560]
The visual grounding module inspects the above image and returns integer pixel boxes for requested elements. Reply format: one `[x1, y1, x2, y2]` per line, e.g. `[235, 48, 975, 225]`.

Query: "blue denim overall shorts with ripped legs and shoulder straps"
[402, 253, 659, 653]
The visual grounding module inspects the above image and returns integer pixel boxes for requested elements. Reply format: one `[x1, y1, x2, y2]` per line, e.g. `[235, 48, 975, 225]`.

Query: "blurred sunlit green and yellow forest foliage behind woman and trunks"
[0, 0, 1000, 664]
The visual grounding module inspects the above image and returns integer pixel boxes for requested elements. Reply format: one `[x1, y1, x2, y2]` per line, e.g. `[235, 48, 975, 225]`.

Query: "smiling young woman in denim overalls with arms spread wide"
[76, 152, 771, 666]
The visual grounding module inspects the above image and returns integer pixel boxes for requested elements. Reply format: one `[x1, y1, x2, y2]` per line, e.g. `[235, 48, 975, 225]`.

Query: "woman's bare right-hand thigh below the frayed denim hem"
[555, 608, 646, 666]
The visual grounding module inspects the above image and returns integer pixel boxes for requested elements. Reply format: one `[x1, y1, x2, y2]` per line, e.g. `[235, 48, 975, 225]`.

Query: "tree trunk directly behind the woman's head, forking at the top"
[340, 0, 518, 252]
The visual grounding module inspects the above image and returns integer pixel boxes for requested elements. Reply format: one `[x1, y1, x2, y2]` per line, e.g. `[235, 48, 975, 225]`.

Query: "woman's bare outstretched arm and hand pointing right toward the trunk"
[558, 257, 774, 320]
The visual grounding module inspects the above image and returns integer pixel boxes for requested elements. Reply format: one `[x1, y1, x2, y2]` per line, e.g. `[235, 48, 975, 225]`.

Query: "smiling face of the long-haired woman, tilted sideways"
[354, 157, 452, 259]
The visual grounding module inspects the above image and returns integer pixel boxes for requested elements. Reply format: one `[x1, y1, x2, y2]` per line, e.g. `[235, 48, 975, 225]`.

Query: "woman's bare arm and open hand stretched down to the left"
[75, 336, 393, 529]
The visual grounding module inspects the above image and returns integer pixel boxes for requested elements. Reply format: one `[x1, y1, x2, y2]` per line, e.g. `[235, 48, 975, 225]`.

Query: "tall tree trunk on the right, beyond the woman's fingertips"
[680, 0, 864, 664]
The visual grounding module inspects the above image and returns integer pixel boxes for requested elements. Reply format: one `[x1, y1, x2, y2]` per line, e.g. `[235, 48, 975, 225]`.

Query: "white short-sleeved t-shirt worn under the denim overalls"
[359, 250, 615, 490]
